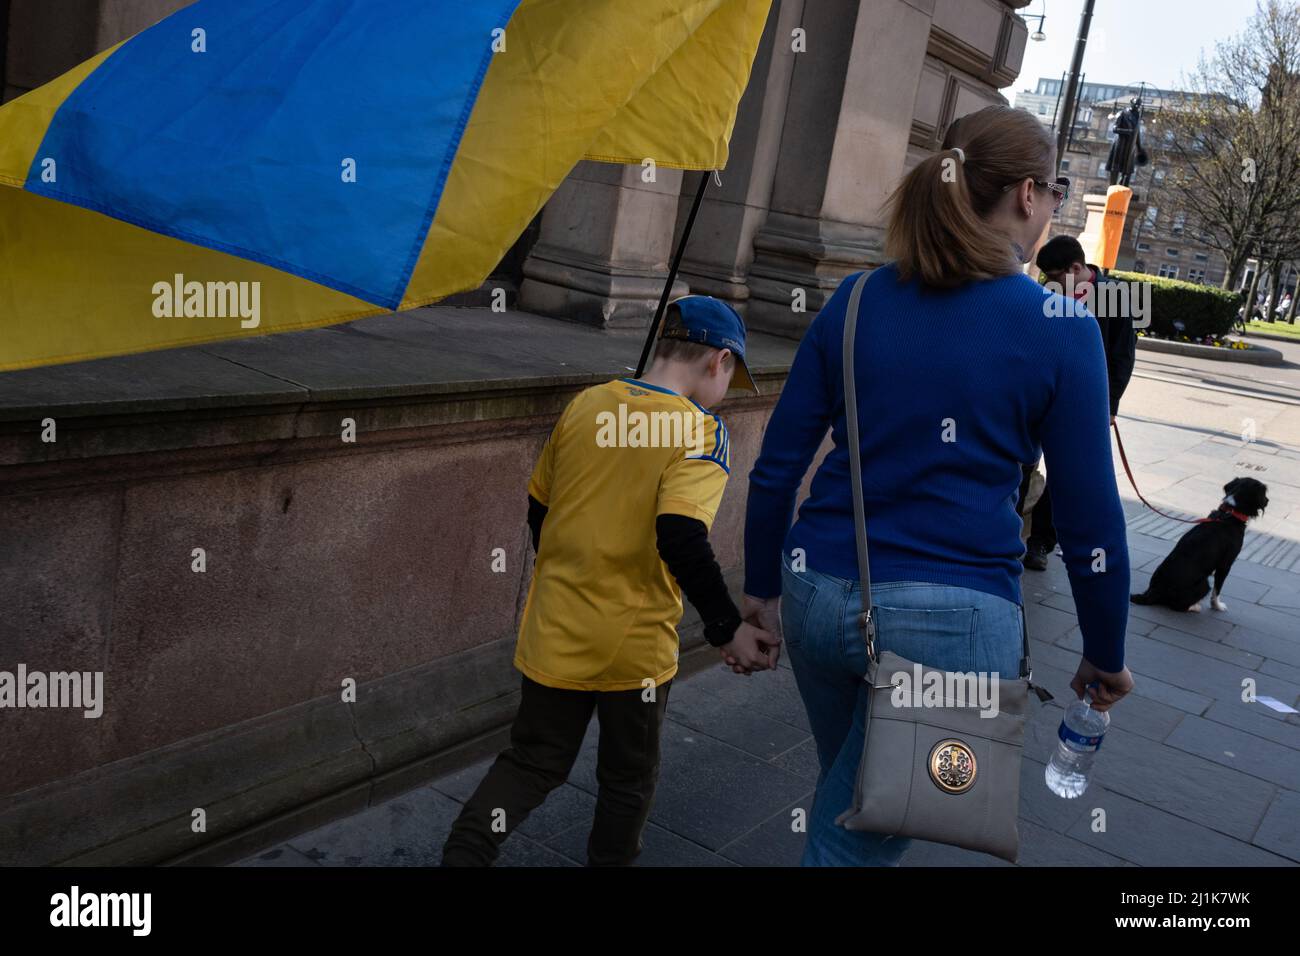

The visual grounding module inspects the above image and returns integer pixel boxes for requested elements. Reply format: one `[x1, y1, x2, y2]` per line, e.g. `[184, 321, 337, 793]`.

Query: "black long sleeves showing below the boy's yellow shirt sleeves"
[528, 494, 741, 648]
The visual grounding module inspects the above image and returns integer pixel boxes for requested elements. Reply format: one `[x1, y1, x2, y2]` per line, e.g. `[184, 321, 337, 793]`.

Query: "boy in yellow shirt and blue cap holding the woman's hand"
[442, 295, 780, 866]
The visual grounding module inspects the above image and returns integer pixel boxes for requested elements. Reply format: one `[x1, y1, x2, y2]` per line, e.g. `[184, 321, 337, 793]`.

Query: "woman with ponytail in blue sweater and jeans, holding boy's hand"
[742, 107, 1132, 866]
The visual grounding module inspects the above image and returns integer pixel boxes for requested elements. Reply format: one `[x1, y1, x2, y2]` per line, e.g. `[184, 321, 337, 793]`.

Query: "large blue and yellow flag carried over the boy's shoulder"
[0, 0, 770, 371]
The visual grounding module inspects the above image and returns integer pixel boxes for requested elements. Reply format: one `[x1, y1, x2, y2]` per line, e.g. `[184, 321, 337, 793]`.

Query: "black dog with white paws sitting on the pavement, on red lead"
[1130, 479, 1269, 611]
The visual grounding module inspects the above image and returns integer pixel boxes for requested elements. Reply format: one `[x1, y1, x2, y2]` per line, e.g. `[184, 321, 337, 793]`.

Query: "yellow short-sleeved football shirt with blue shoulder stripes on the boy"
[515, 378, 731, 691]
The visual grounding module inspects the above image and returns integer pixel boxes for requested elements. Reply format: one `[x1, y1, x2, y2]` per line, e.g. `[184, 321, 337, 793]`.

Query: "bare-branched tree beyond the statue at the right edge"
[1161, 0, 1300, 289]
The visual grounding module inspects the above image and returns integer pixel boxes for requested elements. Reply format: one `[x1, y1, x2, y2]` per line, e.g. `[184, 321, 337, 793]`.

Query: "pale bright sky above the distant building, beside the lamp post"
[1002, 0, 1256, 94]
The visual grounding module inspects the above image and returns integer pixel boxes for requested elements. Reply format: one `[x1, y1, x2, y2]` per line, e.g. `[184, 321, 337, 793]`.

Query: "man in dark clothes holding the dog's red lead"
[1021, 235, 1138, 571]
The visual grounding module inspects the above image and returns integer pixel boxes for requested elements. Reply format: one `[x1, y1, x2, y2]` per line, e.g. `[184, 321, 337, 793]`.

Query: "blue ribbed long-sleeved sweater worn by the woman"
[745, 265, 1128, 671]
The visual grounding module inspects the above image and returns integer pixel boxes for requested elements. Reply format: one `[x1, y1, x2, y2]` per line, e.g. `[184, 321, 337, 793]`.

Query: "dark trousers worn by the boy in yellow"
[442, 678, 672, 866]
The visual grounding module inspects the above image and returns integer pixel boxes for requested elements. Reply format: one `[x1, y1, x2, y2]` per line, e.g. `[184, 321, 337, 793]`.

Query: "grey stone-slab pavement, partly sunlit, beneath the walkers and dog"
[238, 343, 1300, 866]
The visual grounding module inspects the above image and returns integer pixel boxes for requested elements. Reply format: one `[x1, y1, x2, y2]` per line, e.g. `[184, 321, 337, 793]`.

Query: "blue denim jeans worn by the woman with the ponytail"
[781, 558, 1023, 866]
